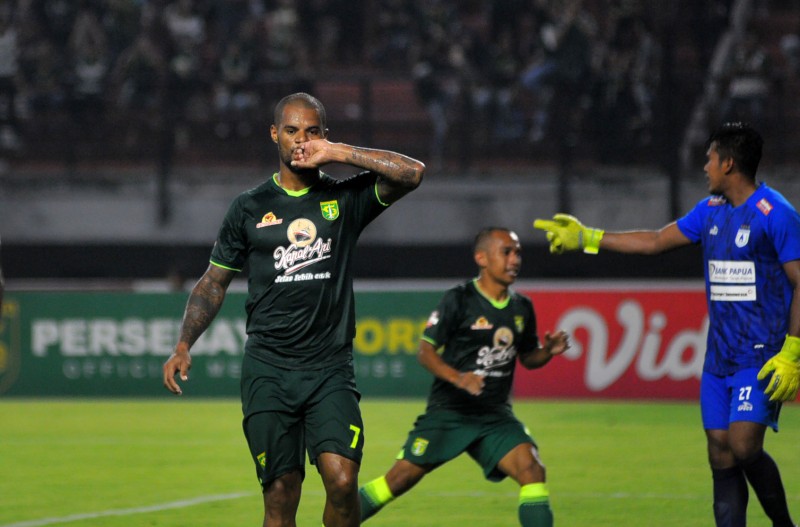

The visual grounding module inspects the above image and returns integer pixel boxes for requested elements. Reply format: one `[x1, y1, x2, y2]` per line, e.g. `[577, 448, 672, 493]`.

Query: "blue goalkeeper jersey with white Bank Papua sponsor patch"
[677, 183, 800, 376]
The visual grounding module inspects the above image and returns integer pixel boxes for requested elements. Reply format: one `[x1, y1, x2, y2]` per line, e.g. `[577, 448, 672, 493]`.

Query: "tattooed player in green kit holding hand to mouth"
[164, 93, 425, 527]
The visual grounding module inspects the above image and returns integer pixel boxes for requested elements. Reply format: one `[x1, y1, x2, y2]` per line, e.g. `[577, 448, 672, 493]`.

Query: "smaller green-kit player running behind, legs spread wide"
[359, 227, 569, 527]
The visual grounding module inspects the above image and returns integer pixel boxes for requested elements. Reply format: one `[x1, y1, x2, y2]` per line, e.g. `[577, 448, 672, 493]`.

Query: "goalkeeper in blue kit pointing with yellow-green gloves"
[534, 123, 800, 527]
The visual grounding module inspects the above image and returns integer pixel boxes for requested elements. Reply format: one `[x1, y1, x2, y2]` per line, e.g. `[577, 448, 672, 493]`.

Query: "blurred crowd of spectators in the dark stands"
[0, 0, 800, 175]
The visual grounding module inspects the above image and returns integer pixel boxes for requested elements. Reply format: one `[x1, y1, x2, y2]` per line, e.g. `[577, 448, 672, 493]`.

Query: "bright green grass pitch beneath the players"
[0, 397, 800, 527]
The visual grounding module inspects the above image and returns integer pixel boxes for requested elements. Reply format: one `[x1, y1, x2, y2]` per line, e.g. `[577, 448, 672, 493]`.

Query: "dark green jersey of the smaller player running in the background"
[422, 280, 539, 413]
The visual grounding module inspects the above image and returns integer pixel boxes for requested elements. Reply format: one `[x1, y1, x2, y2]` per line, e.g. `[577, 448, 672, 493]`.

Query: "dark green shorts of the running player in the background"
[397, 410, 536, 481]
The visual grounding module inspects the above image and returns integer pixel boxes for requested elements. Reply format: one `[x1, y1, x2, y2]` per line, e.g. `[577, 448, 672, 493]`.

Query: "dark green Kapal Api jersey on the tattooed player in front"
[211, 172, 386, 369]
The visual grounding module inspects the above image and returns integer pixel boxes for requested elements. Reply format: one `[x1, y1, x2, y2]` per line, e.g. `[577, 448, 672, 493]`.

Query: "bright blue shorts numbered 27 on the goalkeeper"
[700, 368, 781, 432]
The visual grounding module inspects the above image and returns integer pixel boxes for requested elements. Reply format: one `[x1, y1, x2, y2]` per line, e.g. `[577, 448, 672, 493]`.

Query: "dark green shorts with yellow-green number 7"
[242, 355, 364, 486]
